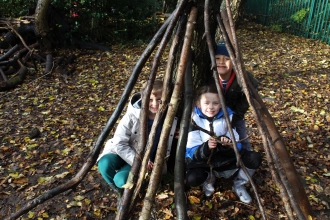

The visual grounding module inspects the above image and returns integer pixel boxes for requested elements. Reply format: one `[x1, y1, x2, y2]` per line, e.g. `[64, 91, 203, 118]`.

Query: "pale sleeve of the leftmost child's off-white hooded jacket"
[112, 113, 135, 166]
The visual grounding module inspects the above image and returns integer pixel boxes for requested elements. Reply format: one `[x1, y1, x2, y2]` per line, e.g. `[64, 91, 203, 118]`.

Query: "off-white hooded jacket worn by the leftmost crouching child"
[97, 93, 177, 166]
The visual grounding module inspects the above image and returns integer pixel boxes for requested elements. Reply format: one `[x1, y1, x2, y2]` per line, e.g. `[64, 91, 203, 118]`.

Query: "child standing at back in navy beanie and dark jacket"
[215, 41, 258, 150]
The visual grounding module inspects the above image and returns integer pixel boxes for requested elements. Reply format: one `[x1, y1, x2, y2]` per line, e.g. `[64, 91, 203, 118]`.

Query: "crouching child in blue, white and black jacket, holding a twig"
[185, 85, 261, 203]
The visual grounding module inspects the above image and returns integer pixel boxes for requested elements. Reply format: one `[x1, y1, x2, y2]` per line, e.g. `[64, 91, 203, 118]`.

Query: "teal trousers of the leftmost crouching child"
[98, 153, 131, 188]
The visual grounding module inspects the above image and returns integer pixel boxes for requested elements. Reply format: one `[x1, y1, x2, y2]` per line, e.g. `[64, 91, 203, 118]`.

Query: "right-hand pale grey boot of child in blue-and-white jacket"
[233, 168, 255, 204]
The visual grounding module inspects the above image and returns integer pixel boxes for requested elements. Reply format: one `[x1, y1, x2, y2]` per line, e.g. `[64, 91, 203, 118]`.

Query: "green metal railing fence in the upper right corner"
[245, 0, 330, 44]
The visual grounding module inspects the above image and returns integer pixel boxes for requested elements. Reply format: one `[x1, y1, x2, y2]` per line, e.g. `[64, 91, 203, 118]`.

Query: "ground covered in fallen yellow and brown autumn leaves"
[0, 23, 330, 220]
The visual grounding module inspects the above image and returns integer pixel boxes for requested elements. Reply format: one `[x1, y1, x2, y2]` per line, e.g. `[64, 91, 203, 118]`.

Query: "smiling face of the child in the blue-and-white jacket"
[197, 93, 221, 117]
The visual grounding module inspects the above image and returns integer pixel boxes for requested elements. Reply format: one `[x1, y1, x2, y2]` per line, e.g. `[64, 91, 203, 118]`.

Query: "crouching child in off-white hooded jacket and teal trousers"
[98, 79, 177, 201]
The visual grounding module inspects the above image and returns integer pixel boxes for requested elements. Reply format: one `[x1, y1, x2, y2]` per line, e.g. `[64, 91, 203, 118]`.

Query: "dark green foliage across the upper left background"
[0, 0, 162, 43]
